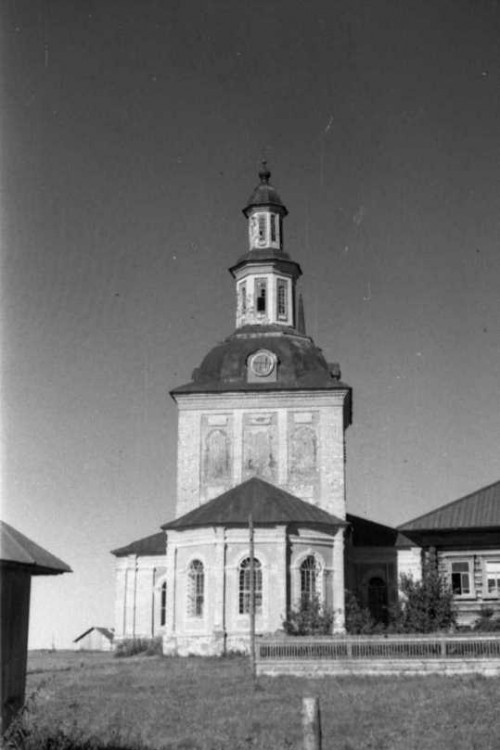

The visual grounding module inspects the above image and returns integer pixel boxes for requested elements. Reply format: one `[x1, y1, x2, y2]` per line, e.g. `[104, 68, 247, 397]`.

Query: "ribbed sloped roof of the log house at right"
[398, 482, 500, 531]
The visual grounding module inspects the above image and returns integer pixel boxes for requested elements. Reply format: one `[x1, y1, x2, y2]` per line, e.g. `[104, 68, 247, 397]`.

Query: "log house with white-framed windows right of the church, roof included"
[398, 482, 500, 625]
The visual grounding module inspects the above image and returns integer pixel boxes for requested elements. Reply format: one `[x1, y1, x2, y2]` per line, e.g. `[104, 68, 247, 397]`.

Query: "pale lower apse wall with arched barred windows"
[164, 526, 344, 655]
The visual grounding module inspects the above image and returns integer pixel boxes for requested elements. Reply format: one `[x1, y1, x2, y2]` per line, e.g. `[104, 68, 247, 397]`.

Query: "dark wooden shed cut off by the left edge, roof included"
[0, 521, 71, 733]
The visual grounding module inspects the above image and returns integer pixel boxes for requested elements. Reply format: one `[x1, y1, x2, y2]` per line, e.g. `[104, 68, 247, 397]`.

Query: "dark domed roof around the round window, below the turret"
[172, 325, 348, 394]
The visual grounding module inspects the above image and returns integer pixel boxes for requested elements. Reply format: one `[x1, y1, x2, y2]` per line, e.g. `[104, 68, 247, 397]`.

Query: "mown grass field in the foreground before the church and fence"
[8, 652, 500, 750]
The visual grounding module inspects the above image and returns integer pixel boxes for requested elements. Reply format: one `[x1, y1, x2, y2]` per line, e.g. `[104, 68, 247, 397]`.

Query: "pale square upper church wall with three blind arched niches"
[176, 391, 345, 519]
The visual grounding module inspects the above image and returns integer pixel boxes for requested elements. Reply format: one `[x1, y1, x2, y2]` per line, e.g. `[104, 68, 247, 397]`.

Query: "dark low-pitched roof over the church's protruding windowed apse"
[162, 477, 347, 529]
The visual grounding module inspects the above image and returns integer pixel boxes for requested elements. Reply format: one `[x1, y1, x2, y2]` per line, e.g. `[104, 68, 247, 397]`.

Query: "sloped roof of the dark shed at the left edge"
[0, 521, 72, 575]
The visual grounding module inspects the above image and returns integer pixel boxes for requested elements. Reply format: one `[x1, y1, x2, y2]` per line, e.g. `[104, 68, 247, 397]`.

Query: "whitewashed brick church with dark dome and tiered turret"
[113, 162, 397, 654]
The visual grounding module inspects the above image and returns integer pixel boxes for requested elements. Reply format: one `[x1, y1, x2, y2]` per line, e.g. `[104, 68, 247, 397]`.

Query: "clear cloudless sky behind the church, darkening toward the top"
[0, 0, 500, 648]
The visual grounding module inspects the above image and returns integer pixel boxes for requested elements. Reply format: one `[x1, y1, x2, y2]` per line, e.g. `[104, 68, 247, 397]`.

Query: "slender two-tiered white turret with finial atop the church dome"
[229, 166, 302, 328]
